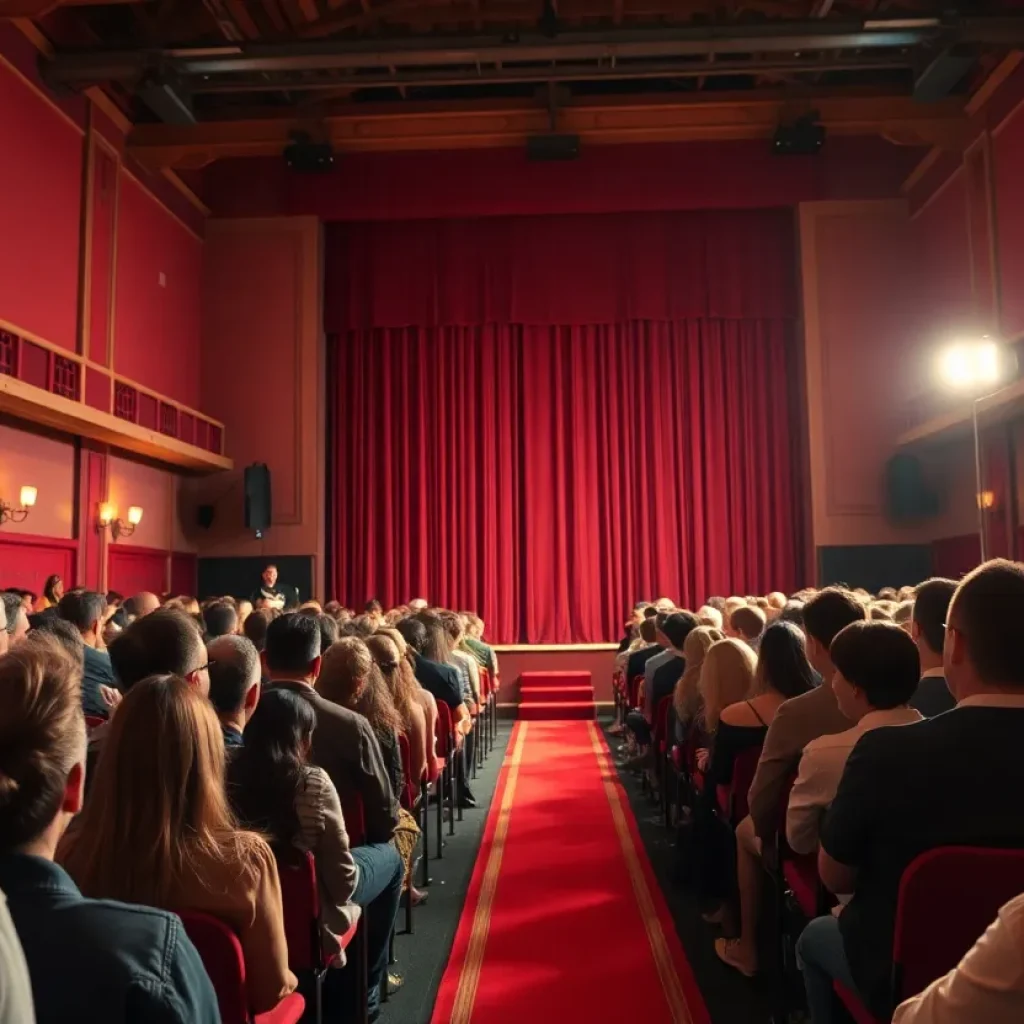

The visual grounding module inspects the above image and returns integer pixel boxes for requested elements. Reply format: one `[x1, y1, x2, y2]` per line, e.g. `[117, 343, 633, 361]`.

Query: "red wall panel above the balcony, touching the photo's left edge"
[0, 48, 83, 349]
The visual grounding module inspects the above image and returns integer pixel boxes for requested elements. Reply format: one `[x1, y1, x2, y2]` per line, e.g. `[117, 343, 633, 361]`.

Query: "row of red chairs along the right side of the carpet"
[613, 674, 1024, 1024]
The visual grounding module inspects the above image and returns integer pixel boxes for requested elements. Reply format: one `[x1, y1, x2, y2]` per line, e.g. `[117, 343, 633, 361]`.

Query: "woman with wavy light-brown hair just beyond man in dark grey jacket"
[316, 637, 426, 903]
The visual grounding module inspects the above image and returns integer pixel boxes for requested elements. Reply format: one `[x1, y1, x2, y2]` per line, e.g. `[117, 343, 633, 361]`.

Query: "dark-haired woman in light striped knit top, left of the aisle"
[227, 688, 359, 967]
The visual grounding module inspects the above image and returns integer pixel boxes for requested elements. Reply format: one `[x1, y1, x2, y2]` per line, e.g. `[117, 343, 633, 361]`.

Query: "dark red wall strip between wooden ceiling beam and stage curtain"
[203, 137, 922, 220]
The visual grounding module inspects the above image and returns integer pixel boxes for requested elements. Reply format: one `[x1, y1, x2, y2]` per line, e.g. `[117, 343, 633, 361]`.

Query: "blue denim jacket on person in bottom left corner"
[0, 854, 220, 1024]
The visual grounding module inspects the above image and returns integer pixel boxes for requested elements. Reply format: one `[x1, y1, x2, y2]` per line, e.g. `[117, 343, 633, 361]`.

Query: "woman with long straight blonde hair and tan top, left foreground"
[57, 676, 297, 1014]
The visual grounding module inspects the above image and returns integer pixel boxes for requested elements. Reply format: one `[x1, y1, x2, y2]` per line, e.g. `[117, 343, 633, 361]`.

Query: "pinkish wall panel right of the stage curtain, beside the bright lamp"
[798, 200, 922, 547]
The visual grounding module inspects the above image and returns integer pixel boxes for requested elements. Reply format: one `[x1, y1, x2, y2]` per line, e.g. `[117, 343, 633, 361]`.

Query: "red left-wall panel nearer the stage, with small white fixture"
[114, 175, 203, 408]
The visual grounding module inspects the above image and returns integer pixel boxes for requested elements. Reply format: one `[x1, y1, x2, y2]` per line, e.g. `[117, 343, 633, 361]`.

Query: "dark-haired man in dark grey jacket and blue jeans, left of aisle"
[263, 612, 404, 1019]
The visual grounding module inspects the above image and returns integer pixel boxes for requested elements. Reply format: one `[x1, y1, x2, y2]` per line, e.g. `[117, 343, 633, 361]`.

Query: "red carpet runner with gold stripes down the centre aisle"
[432, 721, 710, 1024]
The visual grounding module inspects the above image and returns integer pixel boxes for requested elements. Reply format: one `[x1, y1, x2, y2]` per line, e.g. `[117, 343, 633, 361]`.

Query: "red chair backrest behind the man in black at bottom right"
[893, 846, 1024, 1001]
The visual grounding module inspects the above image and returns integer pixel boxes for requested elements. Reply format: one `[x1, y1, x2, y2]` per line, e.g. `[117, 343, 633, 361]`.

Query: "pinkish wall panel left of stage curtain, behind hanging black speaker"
[183, 217, 325, 594]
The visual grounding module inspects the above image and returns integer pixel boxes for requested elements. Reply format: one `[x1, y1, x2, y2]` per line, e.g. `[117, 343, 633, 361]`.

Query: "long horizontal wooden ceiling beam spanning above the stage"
[128, 93, 967, 170]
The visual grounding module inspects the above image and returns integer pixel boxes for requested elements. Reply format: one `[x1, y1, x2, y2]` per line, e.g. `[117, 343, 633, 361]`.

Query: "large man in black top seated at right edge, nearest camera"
[797, 560, 1024, 1024]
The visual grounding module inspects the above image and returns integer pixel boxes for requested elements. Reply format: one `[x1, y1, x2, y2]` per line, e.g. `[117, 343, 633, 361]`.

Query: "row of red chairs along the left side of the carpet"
[180, 670, 498, 1024]
